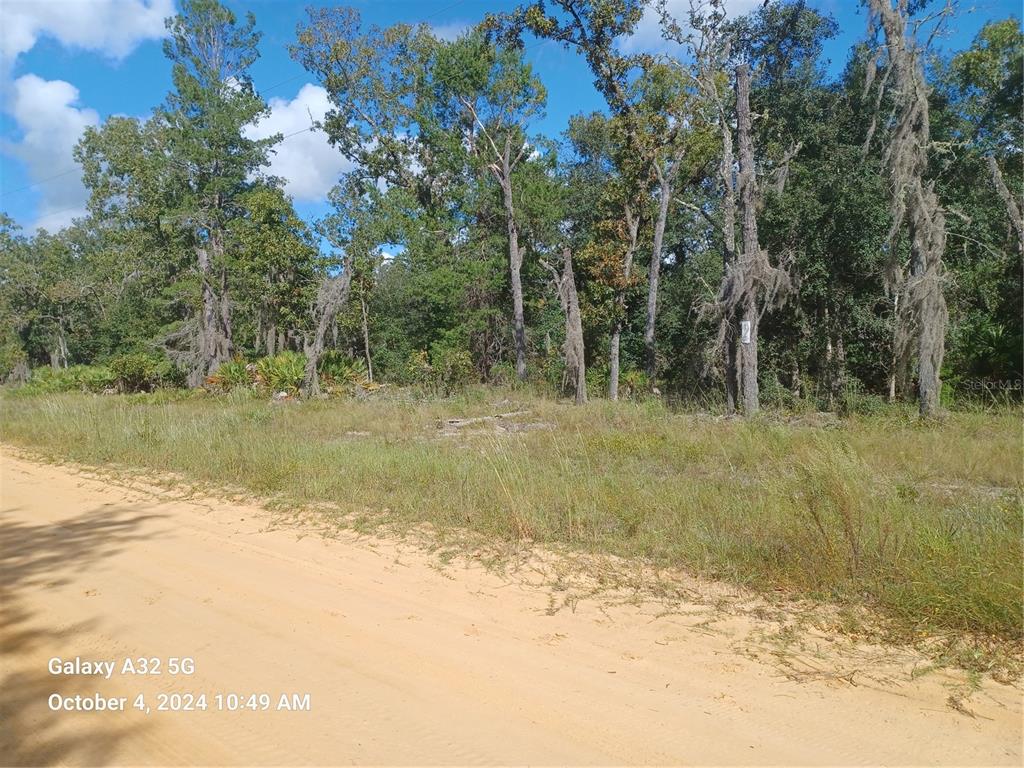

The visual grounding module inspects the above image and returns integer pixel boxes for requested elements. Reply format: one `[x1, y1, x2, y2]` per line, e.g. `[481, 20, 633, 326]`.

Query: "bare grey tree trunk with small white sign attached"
[736, 65, 761, 417]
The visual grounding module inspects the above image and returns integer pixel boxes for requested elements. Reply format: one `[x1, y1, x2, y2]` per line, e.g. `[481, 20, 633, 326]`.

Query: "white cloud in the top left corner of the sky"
[0, 0, 174, 66]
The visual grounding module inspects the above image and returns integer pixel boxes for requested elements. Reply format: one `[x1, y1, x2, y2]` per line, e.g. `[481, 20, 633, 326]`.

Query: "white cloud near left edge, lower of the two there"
[0, 75, 99, 230]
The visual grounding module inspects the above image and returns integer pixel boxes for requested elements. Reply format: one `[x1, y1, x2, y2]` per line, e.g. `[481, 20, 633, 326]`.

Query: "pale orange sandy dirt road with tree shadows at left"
[0, 451, 1021, 765]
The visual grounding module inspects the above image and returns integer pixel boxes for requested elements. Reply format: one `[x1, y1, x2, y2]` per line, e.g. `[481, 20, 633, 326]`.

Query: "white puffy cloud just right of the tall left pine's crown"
[246, 83, 352, 202]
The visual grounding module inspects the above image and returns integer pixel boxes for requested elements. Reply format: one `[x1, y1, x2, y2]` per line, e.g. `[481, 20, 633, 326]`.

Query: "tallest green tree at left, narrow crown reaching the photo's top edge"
[156, 0, 280, 386]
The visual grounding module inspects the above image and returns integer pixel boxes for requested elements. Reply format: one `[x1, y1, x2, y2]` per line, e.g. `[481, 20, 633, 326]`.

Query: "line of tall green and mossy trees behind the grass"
[0, 0, 1024, 415]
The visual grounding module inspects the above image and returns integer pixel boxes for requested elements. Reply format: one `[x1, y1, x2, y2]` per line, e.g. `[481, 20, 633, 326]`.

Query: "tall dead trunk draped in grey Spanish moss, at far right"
[867, 0, 948, 417]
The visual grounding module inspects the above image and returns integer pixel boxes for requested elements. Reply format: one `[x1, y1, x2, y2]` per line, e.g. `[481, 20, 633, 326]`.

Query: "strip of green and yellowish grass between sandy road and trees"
[0, 391, 1022, 642]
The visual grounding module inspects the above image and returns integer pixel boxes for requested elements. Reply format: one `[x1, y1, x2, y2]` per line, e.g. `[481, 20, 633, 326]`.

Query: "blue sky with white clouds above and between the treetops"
[0, 0, 1021, 230]
